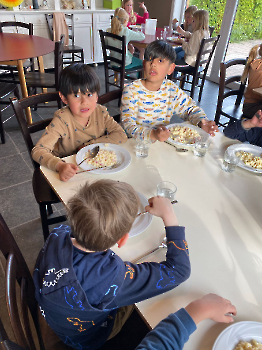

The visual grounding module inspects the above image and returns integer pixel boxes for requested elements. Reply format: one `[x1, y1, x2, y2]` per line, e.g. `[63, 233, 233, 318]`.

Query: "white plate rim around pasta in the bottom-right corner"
[212, 321, 262, 350]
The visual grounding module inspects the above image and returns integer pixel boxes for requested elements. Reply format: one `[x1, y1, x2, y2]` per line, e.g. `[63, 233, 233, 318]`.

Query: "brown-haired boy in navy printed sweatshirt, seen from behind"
[34, 179, 190, 349]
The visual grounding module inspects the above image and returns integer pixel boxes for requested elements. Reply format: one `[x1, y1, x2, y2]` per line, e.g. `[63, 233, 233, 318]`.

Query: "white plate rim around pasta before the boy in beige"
[76, 143, 131, 174]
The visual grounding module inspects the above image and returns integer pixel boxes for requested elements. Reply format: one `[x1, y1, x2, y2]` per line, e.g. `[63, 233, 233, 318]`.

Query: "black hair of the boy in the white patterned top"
[145, 40, 176, 63]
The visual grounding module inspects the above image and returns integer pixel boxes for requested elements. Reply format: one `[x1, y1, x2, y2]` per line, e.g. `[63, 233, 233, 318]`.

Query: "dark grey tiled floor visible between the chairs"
[0, 66, 221, 342]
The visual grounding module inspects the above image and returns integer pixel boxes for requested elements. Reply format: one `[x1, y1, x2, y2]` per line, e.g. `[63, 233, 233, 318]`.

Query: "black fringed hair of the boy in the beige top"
[59, 63, 100, 97]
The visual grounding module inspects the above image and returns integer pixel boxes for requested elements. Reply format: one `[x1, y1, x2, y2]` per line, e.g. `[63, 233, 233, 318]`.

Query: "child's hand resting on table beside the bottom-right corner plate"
[185, 294, 237, 324]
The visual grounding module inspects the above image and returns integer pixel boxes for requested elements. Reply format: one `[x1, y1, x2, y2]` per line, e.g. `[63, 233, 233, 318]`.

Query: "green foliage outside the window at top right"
[190, 0, 262, 43]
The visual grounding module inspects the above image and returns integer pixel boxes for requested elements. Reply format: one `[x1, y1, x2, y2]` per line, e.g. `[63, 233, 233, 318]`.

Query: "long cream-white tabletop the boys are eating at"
[41, 133, 262, 350]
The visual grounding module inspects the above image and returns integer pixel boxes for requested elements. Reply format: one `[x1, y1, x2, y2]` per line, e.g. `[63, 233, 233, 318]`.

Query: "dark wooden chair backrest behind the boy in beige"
[11, 91, 60, 168]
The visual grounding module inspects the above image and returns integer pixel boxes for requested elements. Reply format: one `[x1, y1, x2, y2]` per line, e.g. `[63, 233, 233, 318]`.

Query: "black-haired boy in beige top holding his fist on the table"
[32, 63, 127, 181]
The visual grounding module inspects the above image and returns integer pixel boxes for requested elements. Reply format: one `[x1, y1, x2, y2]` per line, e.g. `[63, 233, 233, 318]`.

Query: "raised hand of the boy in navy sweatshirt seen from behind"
[145, 196, 178, 226]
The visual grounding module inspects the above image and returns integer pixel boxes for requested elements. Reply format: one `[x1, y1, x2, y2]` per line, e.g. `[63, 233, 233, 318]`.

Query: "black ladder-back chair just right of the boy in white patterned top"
[173, 35, 220, 102]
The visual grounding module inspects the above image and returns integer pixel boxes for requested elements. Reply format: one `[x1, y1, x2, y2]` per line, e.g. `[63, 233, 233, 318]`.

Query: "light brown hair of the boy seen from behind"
[67, 179, 140, 251]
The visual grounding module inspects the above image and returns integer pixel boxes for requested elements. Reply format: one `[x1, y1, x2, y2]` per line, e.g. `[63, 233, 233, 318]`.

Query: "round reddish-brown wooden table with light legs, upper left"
[0, 33, 55, 124]
